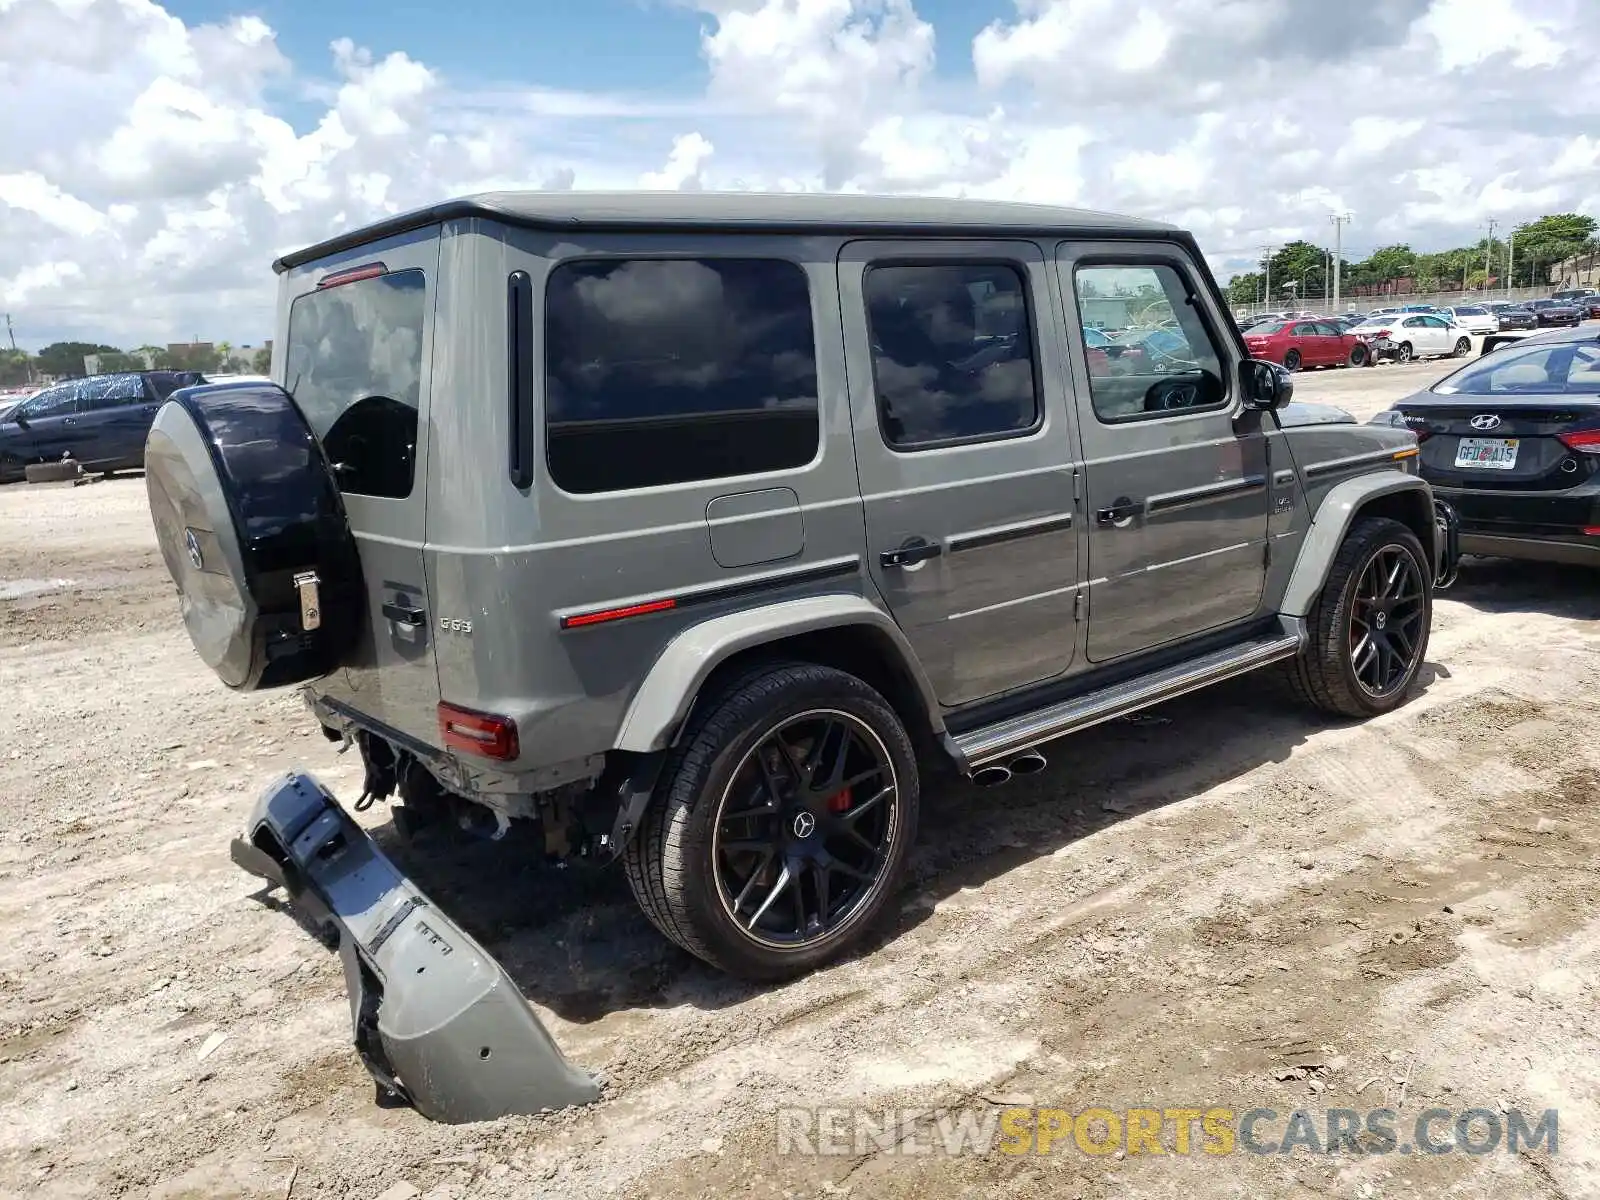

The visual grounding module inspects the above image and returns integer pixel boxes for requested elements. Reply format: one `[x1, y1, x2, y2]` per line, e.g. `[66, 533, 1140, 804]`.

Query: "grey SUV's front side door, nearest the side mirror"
[1058, 243, 1267, 662]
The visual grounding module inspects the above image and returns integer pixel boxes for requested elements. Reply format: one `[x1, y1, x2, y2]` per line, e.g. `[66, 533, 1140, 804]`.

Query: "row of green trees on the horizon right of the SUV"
[1227, 213, 1600, 304]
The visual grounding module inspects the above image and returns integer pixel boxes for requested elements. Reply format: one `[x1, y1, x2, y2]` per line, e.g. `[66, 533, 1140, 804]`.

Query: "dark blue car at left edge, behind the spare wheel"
[0, 371, 200, 483]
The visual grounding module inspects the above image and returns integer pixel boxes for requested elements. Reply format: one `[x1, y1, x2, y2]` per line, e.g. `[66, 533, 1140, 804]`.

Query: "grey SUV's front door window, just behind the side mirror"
[1075, 264, 1227, 421]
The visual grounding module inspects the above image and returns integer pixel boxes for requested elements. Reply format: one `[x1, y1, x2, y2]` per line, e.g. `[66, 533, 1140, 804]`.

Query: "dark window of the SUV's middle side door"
[864, 262, 1038, 450]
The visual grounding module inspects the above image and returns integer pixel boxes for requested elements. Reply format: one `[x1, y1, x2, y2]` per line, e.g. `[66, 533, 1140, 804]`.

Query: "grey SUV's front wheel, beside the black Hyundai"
[1290, 517, 1434, 717]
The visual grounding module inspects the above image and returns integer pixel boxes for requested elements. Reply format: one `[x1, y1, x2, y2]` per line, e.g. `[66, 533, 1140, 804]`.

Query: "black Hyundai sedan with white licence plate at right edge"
[1373, 330, 1600, 566]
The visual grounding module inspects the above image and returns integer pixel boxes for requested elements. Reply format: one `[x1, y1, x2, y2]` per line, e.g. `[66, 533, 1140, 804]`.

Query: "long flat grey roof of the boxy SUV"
[272, 192, 1181, 274]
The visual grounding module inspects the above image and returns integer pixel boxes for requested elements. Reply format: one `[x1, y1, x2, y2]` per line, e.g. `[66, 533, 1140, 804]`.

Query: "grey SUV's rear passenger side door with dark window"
[838, 242, 1082, 706]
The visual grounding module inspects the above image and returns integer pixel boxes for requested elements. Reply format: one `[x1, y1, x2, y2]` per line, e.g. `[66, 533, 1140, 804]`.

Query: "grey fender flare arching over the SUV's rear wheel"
[614, 594, 944, 754]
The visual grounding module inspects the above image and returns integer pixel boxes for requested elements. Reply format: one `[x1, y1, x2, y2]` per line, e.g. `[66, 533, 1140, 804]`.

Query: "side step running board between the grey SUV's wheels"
[952, 621, 1302, 771]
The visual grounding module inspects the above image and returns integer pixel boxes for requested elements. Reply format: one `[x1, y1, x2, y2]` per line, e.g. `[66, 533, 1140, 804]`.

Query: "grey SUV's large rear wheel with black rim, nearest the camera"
[622, 662, 918, 981]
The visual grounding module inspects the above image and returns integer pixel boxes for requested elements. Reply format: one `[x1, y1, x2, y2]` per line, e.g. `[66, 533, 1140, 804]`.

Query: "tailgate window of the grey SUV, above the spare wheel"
[286, 270, 426, 498]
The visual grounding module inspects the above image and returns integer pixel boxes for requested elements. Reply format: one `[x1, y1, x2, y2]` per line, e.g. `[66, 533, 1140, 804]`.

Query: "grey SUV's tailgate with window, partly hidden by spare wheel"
[278, 227, 438, 744]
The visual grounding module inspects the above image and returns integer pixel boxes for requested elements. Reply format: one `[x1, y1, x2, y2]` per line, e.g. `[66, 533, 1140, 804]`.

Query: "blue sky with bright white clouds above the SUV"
[0, 0, 1600, 347]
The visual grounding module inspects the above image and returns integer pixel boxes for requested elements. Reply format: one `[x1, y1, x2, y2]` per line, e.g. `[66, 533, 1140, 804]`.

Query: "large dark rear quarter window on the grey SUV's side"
[544, 259, 819, 493]
